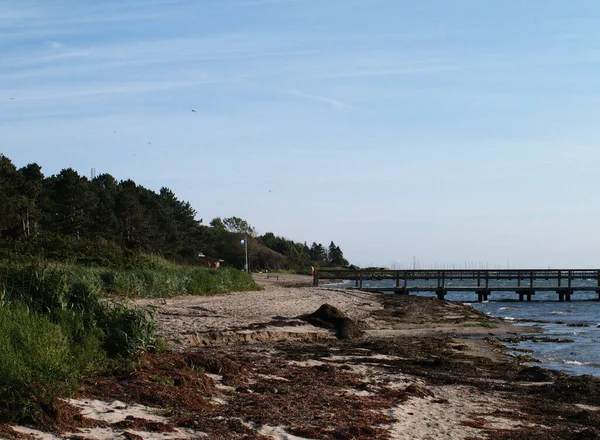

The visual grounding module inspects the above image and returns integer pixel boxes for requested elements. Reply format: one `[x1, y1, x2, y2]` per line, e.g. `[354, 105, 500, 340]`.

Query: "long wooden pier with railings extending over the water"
[313, 269, 600, 302]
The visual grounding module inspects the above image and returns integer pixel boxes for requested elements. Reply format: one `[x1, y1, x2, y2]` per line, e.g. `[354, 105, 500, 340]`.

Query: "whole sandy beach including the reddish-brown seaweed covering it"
[0, 274, 600, 440]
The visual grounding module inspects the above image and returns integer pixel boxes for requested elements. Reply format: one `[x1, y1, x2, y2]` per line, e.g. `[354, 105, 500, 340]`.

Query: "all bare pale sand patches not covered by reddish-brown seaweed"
[8, 274, 596, 440]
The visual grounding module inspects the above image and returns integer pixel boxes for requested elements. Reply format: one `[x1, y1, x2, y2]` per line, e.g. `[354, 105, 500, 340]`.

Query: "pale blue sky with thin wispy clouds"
[0, 0, 600, 268]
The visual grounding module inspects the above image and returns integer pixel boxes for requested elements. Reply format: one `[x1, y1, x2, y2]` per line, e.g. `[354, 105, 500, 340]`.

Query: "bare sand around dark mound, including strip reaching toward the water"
[135, 274, 526, 349]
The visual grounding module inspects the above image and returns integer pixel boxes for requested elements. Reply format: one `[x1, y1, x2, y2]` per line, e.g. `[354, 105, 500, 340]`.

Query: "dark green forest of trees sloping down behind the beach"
[0, 154, 348, 271]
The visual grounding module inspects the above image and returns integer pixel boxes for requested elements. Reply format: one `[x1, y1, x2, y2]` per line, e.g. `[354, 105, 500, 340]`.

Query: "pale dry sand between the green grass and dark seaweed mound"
[135, 274, 383, 349]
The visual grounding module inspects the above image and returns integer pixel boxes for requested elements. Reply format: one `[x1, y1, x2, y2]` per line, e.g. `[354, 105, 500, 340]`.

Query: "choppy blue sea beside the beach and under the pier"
[354, 279, 600, 377]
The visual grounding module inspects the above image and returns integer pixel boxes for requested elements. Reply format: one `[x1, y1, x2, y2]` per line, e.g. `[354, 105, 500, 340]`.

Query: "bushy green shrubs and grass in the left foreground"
[0, 264, 156, 419]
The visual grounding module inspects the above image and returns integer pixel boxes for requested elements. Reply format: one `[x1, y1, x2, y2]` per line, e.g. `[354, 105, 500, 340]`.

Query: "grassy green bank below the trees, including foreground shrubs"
[0, 260, 257, 420]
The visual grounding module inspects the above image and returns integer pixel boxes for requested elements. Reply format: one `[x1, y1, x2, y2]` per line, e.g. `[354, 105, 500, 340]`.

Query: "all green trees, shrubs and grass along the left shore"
[0, 154, 348, 421]
